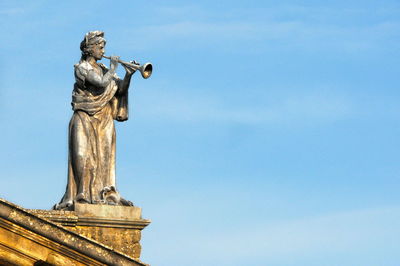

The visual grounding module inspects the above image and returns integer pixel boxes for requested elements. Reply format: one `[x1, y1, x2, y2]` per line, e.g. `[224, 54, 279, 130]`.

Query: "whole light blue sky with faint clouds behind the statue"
[0, 0, 400, 266]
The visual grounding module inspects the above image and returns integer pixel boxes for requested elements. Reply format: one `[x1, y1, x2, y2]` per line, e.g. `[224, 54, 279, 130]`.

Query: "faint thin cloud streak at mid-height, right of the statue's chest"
[141, 89, 356, 125]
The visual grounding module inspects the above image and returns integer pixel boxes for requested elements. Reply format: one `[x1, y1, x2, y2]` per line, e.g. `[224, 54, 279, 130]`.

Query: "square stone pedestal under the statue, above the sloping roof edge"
[30, 203, 150, 259]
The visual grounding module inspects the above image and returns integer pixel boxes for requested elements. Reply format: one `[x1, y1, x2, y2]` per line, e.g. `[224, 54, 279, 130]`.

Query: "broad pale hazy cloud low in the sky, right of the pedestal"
[145, 206, 400, 265]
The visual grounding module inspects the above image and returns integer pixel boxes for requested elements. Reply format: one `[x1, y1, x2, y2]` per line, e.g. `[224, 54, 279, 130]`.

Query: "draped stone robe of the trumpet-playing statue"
[55, 60, 128, 209]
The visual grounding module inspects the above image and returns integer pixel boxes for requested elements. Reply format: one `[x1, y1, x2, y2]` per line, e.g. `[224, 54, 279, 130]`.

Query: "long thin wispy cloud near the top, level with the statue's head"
[133, 21, 400, 50]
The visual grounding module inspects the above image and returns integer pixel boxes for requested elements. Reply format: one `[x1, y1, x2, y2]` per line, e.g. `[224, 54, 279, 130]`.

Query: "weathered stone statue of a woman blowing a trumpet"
[53, 31, 152, 210]
